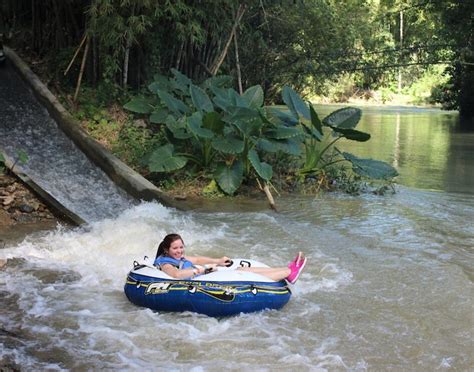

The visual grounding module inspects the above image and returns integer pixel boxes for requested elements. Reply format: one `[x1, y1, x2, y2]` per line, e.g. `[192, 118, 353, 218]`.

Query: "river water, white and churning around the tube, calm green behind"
[0, 104, 474, 371]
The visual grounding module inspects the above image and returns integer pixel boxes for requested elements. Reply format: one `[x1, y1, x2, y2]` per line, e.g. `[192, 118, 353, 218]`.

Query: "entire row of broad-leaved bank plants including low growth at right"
[124, 70, 397, 203]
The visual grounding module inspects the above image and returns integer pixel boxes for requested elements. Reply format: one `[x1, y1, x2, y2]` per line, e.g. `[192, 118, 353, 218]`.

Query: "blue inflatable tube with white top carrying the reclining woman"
[124, 259, 291, 317]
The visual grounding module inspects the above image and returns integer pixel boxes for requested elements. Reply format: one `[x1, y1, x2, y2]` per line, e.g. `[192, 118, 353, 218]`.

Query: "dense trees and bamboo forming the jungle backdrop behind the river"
[0, 0, 474, 126]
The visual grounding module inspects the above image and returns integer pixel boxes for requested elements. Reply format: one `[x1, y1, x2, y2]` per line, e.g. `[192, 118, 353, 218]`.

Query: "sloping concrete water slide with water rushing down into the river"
[0, 48, 184, 224]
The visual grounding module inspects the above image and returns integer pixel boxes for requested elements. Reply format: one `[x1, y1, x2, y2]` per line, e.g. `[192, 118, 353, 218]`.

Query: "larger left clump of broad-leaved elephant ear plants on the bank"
[125, 70, 303, 206]
